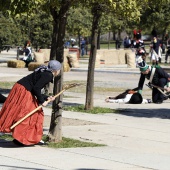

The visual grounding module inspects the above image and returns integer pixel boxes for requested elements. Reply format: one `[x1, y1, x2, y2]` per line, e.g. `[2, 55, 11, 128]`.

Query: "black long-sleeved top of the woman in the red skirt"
[17, 71, 53, 104]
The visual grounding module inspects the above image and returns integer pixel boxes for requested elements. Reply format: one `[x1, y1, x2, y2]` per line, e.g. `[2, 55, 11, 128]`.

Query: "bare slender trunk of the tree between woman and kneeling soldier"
[85, 3, 101, 110]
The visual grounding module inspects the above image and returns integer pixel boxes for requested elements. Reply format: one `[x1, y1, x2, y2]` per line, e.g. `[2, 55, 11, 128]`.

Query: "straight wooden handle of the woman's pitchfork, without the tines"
[10, 89, 66, 130]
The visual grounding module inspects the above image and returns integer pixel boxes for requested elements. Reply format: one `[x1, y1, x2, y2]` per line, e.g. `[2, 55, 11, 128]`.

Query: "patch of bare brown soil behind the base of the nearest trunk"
[44, 116, 101, 126]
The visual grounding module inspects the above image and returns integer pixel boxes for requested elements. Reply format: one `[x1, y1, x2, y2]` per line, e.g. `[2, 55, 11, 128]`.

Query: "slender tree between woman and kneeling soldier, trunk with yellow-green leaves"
[85, 0, 147, 110]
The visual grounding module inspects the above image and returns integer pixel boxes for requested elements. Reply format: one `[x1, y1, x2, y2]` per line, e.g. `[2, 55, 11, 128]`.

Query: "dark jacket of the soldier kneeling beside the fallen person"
[138, 67, 170, 90]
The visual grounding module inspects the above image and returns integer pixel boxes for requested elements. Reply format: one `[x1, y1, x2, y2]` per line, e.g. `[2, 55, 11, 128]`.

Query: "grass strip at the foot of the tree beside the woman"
[0, 134, 106, 148]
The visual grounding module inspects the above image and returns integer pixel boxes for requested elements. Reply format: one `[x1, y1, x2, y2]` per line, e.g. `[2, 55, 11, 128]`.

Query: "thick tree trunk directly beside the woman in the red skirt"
[49, 1, 71, 142]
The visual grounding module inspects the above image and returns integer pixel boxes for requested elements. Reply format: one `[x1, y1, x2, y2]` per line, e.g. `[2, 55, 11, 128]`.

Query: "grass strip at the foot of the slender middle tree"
[63, 105, 116, 114]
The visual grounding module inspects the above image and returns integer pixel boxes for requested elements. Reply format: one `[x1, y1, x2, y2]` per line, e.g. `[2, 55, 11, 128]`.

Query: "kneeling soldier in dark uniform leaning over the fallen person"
[137, 58, 170, 104]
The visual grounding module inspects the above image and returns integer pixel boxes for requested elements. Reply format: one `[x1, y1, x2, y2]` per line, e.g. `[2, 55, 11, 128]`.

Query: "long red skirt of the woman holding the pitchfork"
[0, 83, 44, 145]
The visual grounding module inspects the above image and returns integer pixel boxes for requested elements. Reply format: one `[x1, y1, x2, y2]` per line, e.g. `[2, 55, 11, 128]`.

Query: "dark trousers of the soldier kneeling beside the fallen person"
[152, 78, 167, 103]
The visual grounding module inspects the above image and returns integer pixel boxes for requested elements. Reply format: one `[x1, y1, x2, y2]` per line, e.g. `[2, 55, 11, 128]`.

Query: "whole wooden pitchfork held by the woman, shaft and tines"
[10, 83, 83, 130]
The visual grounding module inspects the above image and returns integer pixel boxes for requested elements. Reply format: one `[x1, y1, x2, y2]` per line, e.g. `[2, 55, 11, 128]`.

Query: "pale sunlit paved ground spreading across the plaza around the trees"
[0, 50, 170, 170]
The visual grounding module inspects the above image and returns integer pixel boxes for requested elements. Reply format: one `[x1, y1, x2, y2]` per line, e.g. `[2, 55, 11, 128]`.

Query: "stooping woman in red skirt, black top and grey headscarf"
[0, 60, 61, 146]
